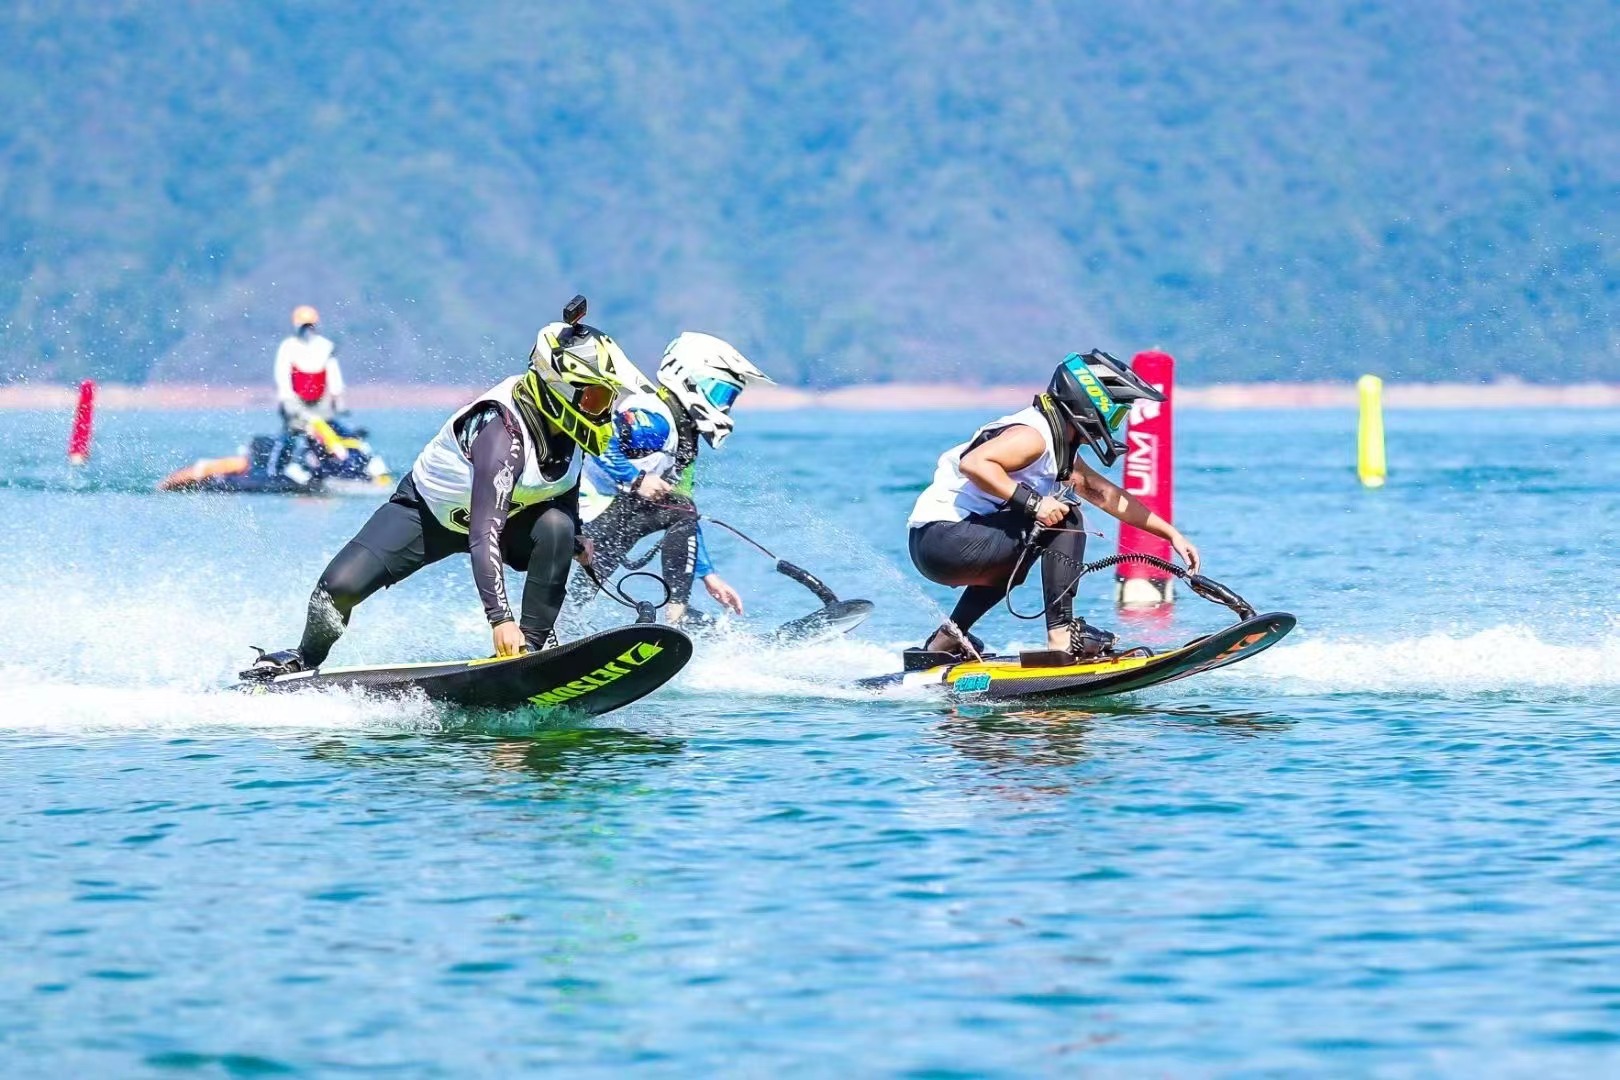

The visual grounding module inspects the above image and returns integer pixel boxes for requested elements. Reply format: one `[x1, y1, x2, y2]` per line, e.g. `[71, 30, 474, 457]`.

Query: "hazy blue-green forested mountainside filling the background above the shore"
[0, 0, 1620, 385]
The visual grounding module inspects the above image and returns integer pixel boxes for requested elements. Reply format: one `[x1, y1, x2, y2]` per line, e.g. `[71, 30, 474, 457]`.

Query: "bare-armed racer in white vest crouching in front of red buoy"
[906, 350, 1199, 667]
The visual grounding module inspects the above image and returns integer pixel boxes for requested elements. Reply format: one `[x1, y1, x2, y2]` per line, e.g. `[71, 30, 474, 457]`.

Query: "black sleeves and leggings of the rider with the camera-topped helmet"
[298, 402, 580, 667]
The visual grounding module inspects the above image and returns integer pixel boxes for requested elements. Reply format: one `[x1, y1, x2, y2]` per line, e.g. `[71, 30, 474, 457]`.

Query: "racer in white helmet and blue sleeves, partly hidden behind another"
[572, 330, 771, 625]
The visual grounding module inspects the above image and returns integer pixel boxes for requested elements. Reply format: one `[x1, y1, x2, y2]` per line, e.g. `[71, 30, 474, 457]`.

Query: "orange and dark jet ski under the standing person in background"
[157, 419, 394, 495]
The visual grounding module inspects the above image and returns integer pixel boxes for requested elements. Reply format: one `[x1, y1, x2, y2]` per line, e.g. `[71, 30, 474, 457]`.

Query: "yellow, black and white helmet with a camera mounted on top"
[515, 298, 651, 455]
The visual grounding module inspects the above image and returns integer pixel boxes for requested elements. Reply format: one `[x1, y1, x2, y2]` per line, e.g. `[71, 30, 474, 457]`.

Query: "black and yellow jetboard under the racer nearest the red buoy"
[860, 612, 1294, 701]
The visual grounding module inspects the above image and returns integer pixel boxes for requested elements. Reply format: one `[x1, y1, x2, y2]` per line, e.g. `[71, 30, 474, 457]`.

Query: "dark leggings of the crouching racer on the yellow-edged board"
[910, 507, 1085, 633]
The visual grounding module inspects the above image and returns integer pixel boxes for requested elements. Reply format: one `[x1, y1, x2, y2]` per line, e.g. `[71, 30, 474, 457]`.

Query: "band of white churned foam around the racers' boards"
[0, 592, 1620, 733]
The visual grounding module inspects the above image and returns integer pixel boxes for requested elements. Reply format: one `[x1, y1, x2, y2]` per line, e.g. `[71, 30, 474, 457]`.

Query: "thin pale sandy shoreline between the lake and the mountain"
[0, 382, 1620, 411]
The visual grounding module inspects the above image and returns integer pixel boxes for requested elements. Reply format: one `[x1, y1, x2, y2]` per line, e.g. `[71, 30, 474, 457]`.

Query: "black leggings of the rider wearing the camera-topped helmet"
[298, 474, 578, 667]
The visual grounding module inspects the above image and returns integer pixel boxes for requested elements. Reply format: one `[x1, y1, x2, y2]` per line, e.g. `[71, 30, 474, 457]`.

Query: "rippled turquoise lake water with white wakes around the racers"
[0, 404, 1620, 1077]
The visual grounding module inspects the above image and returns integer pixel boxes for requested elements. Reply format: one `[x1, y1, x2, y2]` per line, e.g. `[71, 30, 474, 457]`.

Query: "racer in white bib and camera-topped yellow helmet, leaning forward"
[243, 296, 651, 678]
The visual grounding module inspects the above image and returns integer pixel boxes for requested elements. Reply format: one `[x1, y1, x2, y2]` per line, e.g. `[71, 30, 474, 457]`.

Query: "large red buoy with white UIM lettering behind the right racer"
[1118, 351, 1176, 607]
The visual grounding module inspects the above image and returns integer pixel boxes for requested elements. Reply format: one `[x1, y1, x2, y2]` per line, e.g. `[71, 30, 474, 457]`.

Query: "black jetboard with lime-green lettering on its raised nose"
[245, 623, 692, 716]
